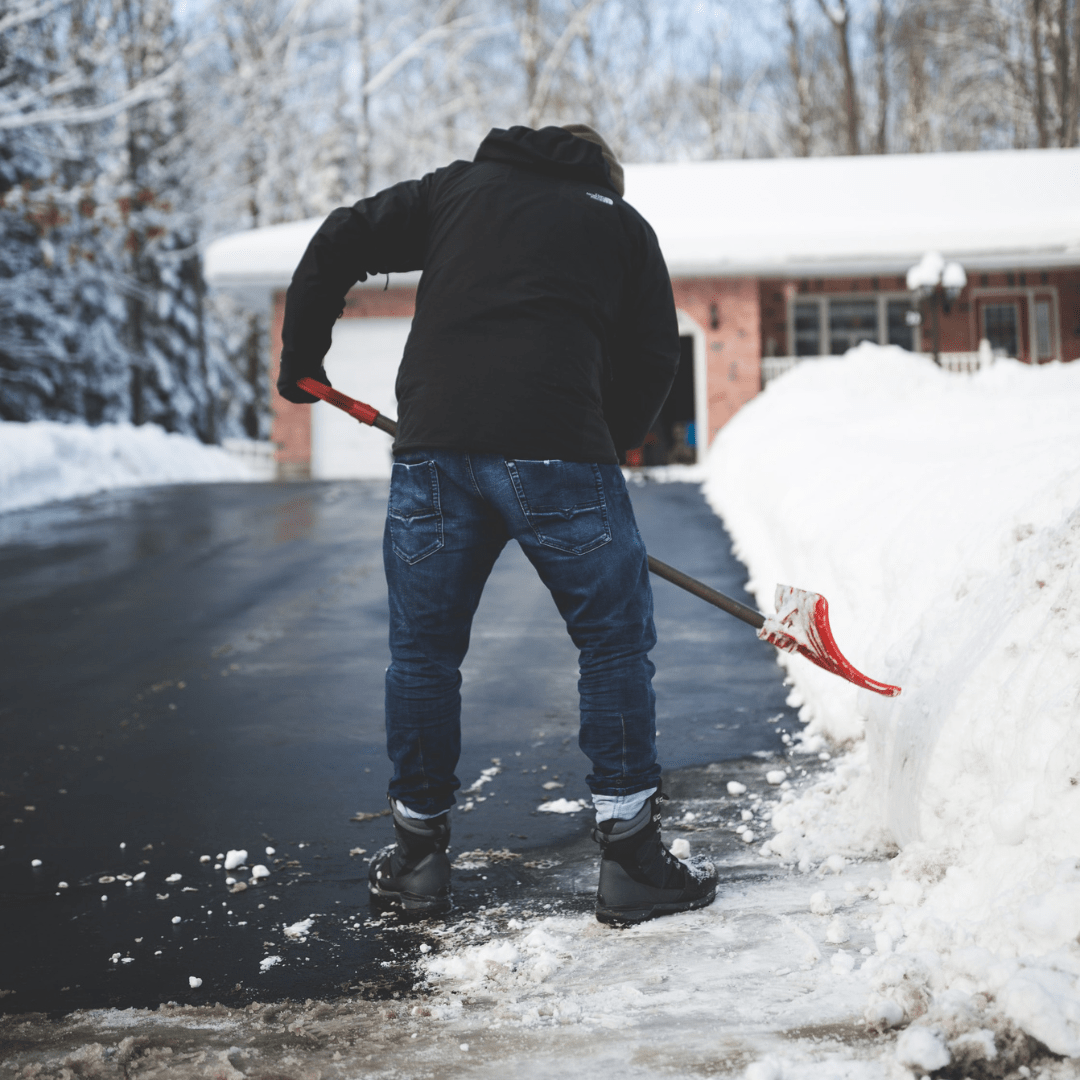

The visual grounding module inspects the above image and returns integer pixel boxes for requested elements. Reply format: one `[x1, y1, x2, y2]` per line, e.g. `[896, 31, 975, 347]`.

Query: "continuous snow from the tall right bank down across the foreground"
[8, 346, 1080, 1080]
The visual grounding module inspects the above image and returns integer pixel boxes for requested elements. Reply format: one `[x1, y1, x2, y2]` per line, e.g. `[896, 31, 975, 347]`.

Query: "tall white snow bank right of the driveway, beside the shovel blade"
[705, 345, 1080, 1056]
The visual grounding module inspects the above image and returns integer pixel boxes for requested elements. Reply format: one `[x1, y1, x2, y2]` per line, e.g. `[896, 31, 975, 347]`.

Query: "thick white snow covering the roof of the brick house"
[206, 149, 1080, 300]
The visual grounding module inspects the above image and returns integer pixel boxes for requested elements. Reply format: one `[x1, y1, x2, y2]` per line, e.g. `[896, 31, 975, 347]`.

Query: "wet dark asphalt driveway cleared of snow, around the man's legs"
[0, 473, 795, 1013]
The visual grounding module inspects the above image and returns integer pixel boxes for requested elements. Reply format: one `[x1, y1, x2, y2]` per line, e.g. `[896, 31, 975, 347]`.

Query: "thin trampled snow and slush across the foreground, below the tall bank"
[0, 777, 924, 1080]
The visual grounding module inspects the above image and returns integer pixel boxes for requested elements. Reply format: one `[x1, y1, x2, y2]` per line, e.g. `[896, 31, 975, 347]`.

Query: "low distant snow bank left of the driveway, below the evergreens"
[0, 420, 264, 512]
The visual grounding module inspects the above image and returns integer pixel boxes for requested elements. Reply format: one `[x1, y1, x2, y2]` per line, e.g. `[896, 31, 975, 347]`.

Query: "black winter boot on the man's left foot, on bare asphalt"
[367, 801, 454, 915]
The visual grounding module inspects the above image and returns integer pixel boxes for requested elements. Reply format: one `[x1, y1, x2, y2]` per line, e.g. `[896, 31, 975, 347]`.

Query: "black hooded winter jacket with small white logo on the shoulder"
[279, 127, 679, 462]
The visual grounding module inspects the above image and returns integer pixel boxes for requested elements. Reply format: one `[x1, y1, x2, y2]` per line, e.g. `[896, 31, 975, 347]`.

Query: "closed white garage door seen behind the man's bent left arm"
[311, 319, 413, 480]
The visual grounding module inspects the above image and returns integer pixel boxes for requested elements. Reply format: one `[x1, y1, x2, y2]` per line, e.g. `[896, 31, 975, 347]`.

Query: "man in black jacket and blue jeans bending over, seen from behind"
[278, 125, 716, 922]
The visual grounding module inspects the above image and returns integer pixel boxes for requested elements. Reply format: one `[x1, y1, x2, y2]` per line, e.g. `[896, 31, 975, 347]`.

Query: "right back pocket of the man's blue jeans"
[507, 460, 611, 555]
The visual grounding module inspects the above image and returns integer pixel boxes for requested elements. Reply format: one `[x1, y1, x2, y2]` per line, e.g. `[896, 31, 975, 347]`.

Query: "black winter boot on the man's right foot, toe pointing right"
[593, 791, 716, 923]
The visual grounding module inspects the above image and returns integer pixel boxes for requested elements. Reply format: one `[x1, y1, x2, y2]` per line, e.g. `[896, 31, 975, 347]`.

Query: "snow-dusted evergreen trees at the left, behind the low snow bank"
[0, 0, 247, 441]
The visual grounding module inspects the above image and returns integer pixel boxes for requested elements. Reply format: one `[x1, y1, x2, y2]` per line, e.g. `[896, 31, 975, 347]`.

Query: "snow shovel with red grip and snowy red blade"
[297, 378, 900, 698]
